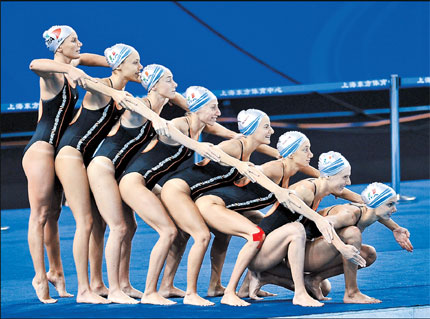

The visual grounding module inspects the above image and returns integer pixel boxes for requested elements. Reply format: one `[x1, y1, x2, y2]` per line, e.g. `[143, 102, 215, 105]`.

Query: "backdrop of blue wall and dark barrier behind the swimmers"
[1, 1, 430, 209]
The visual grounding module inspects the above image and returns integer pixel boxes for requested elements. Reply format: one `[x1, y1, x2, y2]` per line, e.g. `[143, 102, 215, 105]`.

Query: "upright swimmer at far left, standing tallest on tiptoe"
[22, 25, 107, 303]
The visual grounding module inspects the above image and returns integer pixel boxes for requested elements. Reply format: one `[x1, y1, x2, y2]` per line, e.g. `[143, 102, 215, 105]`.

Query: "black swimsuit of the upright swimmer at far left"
[24, 77, 79, 154]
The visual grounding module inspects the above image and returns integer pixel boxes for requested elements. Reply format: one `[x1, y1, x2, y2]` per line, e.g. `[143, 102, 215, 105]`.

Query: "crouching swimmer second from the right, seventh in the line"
[242, 152, 364, 306]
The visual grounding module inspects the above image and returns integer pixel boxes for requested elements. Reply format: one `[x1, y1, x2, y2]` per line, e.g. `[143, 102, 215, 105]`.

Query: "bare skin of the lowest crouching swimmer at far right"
[254, 196, 413, 304]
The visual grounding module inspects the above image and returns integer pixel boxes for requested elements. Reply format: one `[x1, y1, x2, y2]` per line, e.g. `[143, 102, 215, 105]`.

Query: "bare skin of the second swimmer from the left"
[55, 51, 142, 303]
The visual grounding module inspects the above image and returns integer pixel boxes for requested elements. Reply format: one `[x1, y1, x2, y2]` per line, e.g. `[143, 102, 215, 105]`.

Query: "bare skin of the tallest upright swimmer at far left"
[22, 33, 107, 303]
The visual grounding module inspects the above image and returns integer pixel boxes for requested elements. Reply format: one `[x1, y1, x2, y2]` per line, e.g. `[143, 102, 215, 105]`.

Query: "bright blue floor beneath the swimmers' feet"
[1, 180, 430, 318]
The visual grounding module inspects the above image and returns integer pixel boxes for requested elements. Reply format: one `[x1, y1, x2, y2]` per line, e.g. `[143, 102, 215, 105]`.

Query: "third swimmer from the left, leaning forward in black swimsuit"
[87, 65, 188, 303]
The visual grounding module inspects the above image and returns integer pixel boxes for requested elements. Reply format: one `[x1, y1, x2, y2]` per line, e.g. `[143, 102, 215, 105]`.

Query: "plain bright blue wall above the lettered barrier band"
[1, 1, 430, 103]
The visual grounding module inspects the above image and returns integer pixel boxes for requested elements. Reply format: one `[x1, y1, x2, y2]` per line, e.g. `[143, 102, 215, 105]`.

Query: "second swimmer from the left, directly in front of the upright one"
[55, 44, 147, 303]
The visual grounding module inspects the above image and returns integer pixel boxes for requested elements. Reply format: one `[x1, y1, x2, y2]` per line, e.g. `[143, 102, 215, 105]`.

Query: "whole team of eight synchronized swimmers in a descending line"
[22, 25, 413, 307]
